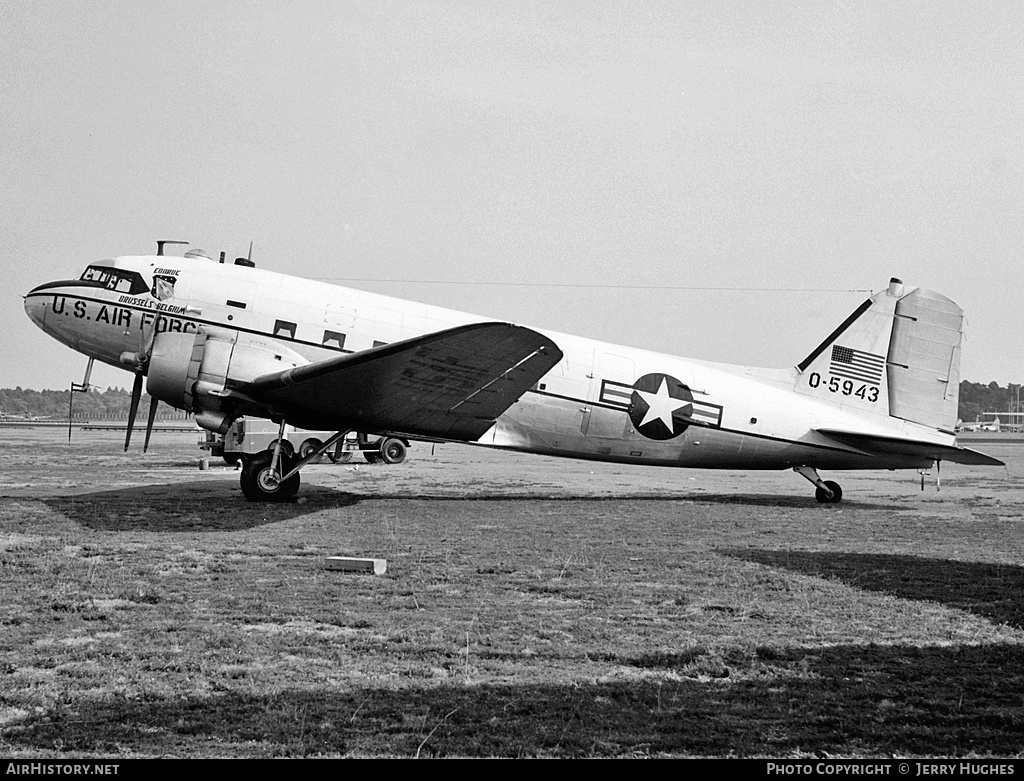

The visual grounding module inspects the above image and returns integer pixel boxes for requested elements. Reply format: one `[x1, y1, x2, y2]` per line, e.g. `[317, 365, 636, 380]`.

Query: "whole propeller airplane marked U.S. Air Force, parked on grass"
[25, 242, 1002, 504]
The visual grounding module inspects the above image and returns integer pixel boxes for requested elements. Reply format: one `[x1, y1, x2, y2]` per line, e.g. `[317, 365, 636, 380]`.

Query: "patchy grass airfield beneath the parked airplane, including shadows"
[0, 429, 1024, 757]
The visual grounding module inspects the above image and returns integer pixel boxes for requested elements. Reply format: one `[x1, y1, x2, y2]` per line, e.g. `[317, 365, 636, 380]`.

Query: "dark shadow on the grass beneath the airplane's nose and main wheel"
[42, 481, 361, 531]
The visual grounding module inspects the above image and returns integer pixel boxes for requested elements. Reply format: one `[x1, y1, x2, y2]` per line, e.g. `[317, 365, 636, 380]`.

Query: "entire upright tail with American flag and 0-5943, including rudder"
[795, 279, 964, 434]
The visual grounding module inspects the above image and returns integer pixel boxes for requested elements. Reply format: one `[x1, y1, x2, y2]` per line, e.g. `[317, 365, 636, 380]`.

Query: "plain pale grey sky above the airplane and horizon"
[0, 0, 1024, 389]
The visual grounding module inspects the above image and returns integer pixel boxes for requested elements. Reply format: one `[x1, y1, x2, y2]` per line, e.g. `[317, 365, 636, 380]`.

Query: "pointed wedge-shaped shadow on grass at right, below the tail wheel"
[716, 549, 1024, 628]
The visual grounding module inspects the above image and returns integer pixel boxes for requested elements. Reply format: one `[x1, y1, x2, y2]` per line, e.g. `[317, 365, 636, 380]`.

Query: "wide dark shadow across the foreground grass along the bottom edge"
[8, 644, 1024, 762]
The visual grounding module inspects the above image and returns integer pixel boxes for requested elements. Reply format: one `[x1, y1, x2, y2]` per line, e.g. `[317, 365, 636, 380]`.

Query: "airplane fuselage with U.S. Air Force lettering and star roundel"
[25, 256, 954, 469]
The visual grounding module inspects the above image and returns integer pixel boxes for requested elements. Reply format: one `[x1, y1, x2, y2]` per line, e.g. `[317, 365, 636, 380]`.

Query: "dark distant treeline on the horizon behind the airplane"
[0, 380, 1020, 423]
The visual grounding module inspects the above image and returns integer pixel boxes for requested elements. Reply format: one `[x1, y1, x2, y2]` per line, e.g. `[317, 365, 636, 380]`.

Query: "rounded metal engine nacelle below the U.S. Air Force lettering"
[146, 332, 309, 434]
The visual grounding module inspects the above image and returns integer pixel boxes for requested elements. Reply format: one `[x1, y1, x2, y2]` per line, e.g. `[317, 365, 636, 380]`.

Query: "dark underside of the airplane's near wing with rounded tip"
[232, 322, 562, 440]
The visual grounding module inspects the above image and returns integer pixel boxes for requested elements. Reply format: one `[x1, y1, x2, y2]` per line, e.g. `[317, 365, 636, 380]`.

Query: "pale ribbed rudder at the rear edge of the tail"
[887, 288, 964, 434]
